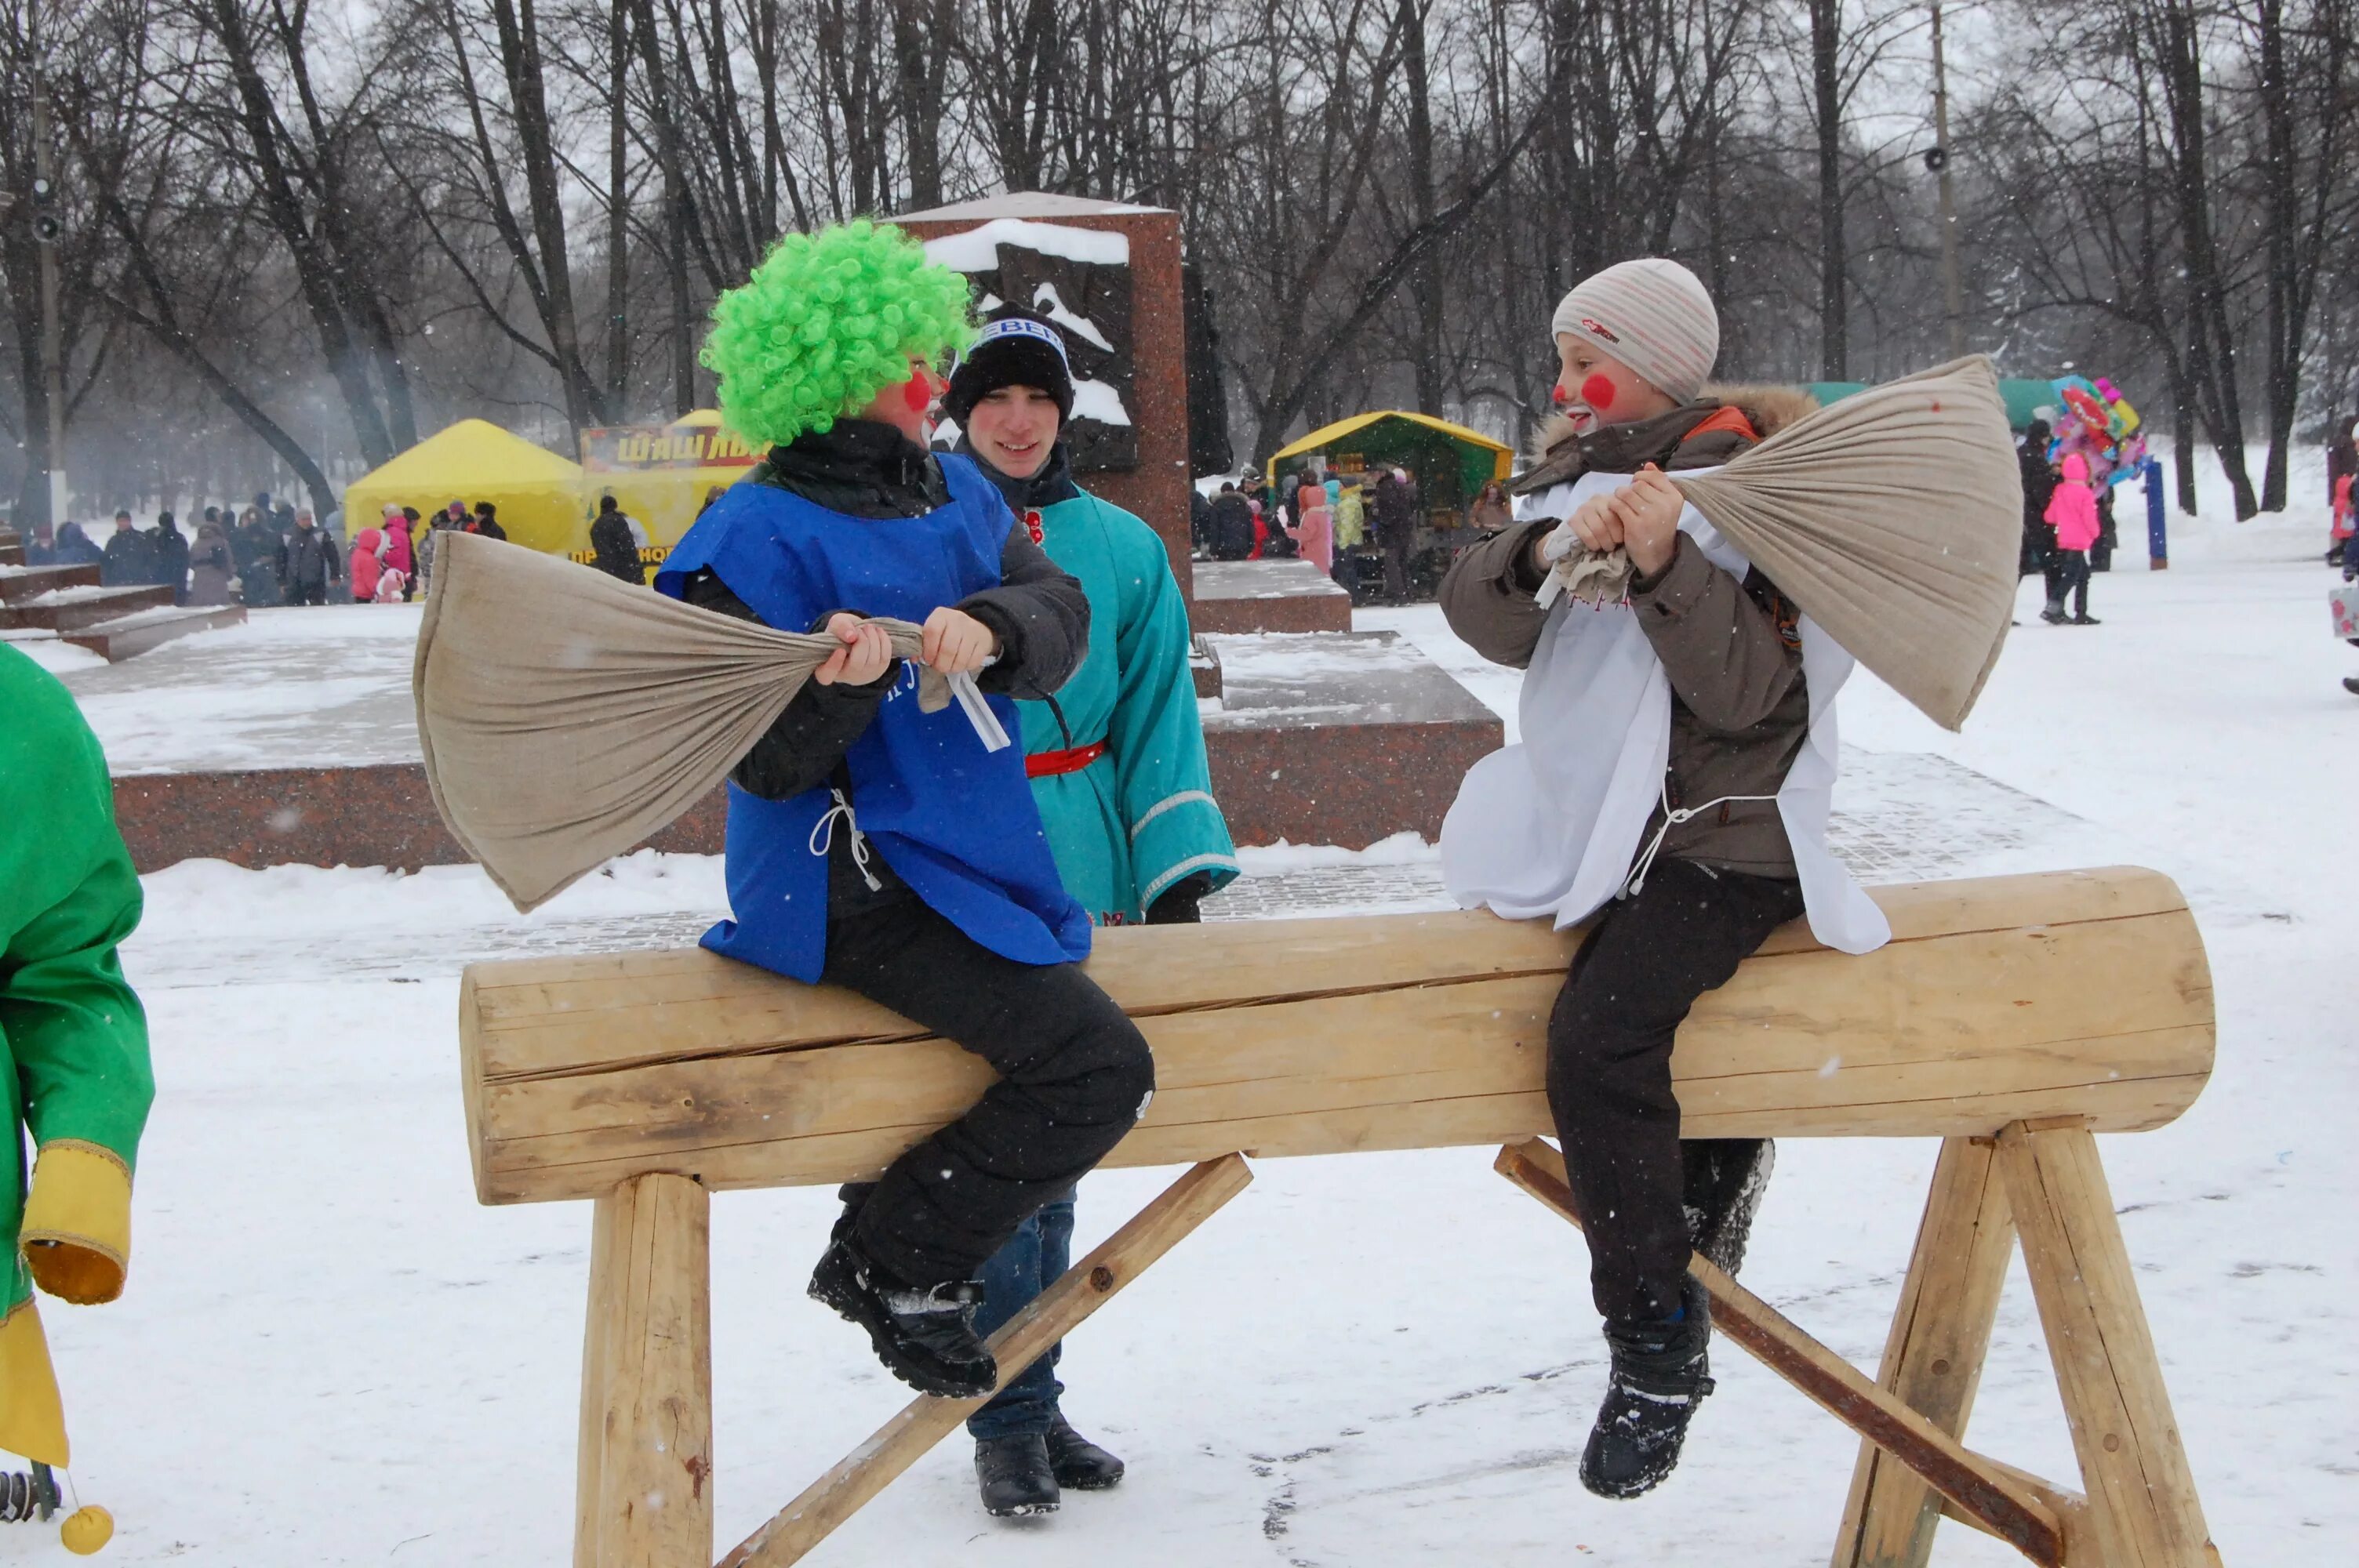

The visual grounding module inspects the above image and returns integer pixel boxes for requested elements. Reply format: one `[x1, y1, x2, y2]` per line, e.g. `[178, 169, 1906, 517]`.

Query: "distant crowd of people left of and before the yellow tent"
[26, 491, 507, 608]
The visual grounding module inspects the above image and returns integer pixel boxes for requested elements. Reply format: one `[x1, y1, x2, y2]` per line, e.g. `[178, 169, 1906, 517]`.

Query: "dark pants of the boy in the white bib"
[1547, 861, 1802, 1325]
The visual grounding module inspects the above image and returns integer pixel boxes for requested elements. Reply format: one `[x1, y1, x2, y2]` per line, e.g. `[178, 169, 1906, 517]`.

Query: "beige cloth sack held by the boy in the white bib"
[1543, 354, 2024, 728]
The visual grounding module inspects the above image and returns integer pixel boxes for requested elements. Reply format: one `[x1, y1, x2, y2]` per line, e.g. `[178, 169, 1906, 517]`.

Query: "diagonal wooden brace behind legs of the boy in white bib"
[1493, 1139, 2076, 1568]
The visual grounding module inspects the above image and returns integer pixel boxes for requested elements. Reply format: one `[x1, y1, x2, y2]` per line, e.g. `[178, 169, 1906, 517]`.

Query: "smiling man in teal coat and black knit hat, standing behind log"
[941, 307, 1236, 1516]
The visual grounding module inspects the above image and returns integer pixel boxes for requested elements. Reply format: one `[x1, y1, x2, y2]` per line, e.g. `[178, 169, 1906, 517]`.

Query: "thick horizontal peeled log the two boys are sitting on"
[460, 870, 2215, 1203]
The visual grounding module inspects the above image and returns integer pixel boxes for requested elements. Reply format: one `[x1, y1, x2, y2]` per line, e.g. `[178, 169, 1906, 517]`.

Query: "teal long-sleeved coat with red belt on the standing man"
[1016, 493, 1236, 924]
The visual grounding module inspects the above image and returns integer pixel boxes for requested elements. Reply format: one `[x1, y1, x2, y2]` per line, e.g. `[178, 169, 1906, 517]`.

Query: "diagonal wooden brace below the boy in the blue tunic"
[707, 1156, 1252, 1568]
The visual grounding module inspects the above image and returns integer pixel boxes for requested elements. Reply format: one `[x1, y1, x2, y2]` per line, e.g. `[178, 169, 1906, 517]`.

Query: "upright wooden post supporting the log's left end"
[573, 1174, 712, 1568]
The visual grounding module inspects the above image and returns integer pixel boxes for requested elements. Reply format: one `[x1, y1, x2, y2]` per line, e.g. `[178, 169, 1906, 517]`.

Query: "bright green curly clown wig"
[700, 220, 972, 445]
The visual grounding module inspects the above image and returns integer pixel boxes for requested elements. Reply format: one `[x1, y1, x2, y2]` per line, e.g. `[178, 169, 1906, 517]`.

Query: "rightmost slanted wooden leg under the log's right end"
[1998, 1123, 2220, 1568]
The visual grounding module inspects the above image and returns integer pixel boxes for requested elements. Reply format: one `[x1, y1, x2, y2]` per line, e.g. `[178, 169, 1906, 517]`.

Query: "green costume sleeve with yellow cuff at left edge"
[0, 648, 156, 1306]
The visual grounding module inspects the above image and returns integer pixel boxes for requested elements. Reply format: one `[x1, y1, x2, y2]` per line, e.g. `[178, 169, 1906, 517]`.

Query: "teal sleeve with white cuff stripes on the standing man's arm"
[1107, 507, 1236, 908]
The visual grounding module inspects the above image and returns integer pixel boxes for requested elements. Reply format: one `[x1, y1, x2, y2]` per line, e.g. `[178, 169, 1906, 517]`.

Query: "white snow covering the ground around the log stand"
[23, 495, 2359, 1568]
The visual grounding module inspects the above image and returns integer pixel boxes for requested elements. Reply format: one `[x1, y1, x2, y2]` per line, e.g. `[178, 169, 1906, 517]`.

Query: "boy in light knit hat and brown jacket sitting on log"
[1441, 260, 1812, 1497]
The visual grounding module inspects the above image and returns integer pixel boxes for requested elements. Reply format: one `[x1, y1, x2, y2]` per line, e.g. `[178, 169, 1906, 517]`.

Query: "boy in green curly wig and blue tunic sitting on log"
[656, 222, 1154, 1398]
